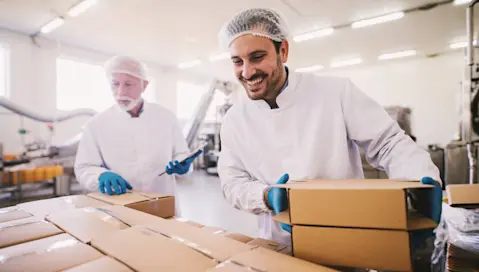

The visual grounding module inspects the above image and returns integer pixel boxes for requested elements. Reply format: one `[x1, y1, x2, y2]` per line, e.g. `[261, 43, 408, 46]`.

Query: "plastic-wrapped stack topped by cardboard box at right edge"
[433, 184, 479, 272]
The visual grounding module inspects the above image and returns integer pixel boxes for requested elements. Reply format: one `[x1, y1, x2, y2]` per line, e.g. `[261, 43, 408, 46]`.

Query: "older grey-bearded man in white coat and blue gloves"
[75, 56, 201, 215]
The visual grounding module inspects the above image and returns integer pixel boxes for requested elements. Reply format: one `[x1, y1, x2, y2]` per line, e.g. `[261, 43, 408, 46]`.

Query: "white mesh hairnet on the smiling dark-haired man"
[218, 8, 290, 50]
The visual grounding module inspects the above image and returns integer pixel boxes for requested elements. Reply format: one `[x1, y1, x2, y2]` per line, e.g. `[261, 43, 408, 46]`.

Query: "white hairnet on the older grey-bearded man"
[105, 56, 148, 80]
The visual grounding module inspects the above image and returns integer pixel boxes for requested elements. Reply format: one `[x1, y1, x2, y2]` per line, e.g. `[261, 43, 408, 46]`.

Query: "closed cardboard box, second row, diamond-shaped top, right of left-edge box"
[46, 207, 129, 243]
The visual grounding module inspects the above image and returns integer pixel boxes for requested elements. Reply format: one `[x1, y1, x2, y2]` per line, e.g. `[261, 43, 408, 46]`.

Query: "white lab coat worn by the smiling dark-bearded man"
[218, 72, 439, 244]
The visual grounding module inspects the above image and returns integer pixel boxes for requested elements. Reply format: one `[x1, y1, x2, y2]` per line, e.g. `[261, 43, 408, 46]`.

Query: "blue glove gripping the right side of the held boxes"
[411, 177, 442, 248]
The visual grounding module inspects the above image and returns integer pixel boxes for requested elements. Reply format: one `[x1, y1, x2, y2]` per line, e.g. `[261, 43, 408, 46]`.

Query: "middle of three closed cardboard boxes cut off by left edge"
[0, 216, 63, 248]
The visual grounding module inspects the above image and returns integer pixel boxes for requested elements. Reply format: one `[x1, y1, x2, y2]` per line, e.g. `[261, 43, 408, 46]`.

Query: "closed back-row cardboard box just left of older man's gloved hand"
[17, 195, 109, 218]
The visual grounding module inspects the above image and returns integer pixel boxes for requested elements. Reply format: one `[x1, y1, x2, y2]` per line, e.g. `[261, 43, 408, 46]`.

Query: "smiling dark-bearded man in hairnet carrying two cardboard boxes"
[218, 8, 442, 246]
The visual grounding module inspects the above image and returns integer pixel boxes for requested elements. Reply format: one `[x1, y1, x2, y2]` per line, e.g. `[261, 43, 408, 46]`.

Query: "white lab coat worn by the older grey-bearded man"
[75, 101, 189, 215]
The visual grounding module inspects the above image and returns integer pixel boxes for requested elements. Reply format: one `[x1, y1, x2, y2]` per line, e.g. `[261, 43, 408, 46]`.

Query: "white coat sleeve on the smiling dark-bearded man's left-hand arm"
[218, 119, 270, 214]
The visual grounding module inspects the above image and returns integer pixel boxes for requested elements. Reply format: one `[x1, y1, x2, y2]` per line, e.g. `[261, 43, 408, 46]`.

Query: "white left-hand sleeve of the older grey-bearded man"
[74, 125, 108, 191]
